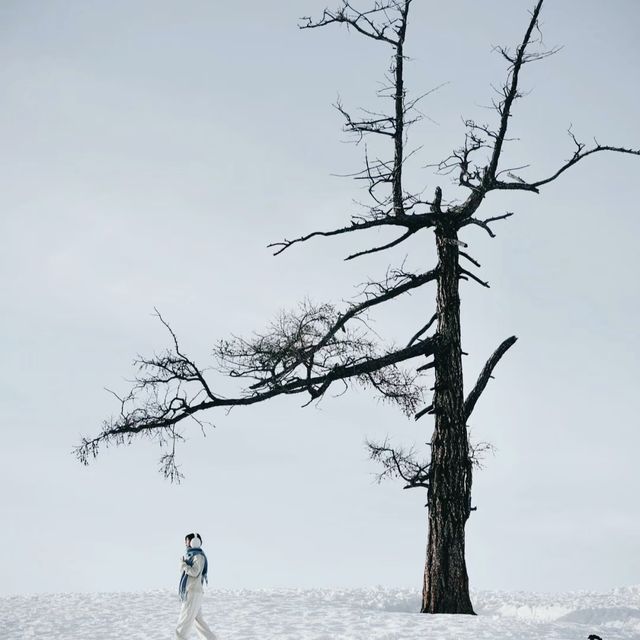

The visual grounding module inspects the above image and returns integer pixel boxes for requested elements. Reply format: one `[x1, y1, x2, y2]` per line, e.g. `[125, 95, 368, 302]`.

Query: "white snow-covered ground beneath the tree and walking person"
[0, 586, 640, 640]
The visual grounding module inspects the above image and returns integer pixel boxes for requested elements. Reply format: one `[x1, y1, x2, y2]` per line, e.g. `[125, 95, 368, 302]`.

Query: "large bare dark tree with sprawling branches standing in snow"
[77, 0, 640, 614]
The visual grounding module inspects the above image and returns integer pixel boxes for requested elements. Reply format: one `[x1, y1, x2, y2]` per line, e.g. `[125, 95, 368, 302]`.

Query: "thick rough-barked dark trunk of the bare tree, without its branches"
[421, 225, 474, 614]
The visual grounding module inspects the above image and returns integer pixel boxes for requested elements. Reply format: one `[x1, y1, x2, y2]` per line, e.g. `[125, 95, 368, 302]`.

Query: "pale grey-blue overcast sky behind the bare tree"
[0, 0, 640, 594]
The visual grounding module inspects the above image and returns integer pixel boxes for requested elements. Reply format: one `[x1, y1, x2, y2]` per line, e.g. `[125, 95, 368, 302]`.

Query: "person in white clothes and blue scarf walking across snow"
[176, 533, 218, 640]
